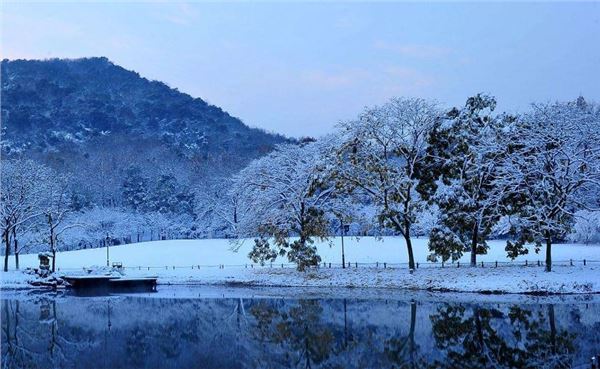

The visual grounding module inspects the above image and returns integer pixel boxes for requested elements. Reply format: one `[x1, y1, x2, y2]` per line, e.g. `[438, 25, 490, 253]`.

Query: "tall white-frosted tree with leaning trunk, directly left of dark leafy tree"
[333, 98, 439, 271]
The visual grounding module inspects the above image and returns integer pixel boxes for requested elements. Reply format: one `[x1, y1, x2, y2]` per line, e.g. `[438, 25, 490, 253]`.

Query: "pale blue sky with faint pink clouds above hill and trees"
[0, 1, 600, 137]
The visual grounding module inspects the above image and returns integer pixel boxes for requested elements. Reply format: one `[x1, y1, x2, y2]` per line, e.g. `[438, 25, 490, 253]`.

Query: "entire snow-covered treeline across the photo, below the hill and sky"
[0, 94, 600, 270]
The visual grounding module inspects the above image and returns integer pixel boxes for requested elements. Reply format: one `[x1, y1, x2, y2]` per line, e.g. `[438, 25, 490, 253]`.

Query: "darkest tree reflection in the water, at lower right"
[430, 305, 576, 368]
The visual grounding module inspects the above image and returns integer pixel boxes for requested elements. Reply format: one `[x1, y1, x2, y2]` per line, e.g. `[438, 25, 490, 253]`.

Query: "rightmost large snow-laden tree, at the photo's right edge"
[499, 99, 600, 271]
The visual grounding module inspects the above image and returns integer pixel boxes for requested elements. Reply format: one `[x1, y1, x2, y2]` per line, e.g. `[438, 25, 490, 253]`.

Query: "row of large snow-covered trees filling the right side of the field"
[230, 94, 600, 272]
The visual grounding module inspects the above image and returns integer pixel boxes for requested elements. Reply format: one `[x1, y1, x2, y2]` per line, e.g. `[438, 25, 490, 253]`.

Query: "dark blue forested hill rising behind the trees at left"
[1, 58, 288, 204]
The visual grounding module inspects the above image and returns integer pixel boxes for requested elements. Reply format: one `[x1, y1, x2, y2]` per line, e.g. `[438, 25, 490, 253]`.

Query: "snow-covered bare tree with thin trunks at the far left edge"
[0, 159, 50, 271]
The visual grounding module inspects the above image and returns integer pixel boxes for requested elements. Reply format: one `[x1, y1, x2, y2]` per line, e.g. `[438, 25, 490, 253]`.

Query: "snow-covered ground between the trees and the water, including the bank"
[1, 237, 600, 293]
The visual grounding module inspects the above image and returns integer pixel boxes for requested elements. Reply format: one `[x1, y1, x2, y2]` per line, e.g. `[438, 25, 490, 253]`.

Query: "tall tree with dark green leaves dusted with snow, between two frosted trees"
[420, 94, 509, 266]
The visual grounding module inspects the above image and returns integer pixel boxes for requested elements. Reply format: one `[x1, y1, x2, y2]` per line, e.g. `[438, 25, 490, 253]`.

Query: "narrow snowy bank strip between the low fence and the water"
[1, 265, 600, 294]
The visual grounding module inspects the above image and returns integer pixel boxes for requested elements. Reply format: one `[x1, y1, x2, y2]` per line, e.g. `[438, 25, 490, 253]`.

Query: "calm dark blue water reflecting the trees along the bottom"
[0, 287, 600, 368]
